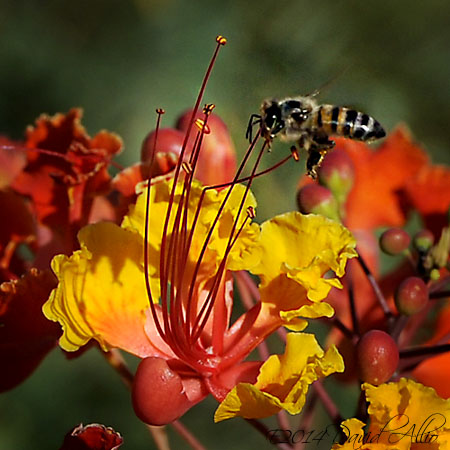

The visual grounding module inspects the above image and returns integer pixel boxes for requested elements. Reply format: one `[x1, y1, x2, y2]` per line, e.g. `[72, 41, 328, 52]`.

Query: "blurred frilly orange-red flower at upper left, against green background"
[12, 109, 122, 231]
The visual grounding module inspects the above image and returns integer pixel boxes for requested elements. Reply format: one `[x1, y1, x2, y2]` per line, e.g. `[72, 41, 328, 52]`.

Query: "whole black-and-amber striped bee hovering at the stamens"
[246, 93, 386, 178]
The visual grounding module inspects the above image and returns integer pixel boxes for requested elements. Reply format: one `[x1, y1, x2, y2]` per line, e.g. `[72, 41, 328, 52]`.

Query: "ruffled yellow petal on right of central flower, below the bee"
[251, 212, 357, 320]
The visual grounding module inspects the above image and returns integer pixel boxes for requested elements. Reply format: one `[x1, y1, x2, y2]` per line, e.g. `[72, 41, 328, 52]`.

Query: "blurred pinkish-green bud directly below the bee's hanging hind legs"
[319, 149, 355, 205]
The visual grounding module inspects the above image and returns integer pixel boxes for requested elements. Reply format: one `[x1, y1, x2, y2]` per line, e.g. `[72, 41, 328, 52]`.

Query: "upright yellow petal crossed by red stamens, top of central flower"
[122, 181, 260, 297]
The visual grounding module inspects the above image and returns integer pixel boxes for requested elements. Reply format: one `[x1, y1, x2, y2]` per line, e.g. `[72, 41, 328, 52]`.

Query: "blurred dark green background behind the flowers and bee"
[0, 0, 450, 450]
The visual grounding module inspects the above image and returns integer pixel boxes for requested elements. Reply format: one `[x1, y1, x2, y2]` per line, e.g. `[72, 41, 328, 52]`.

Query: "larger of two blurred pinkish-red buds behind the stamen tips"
[176, 110, 236, 185]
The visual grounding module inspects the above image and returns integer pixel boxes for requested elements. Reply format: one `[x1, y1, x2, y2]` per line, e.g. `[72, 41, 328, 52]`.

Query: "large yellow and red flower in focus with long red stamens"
[44, 39, 356, 425]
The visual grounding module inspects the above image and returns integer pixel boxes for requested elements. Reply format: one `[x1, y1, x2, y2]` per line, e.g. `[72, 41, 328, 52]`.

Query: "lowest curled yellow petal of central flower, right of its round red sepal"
[214, 333, 344, 422]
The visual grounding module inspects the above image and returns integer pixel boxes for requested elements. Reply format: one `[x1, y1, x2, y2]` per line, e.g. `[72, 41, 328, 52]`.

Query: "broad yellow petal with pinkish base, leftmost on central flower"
[43, 222, 153, 356]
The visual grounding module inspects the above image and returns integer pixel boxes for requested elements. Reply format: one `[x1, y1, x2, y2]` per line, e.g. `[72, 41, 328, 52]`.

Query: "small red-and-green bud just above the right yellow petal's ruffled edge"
[297, 183, 340, 222]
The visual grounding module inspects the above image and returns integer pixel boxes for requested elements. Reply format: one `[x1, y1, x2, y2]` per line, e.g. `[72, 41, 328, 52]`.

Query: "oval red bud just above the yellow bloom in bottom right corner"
[357, 330, 399, 386]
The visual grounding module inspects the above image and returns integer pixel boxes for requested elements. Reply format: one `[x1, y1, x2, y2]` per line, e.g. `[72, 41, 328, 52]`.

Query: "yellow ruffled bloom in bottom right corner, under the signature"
[333, 378, 450, 450]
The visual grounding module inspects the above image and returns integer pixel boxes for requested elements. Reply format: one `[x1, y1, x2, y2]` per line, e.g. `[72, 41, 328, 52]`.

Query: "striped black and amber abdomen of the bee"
[313, 105, 386, 141]
